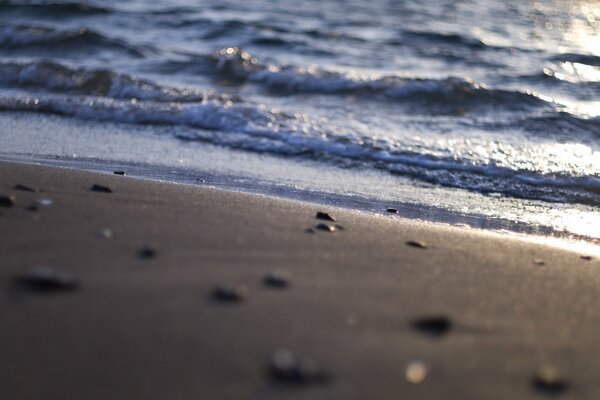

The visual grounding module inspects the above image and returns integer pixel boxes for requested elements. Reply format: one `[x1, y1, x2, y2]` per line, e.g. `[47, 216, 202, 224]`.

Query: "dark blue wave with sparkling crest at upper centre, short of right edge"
[214, 47, 552, 110]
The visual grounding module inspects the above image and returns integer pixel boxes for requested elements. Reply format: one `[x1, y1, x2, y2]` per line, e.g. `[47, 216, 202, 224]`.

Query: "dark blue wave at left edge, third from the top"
[0, 61, 229, 103]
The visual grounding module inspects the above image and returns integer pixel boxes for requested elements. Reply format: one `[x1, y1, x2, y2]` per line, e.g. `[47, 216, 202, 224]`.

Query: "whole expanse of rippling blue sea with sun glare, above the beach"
[0, 0, 600, 239]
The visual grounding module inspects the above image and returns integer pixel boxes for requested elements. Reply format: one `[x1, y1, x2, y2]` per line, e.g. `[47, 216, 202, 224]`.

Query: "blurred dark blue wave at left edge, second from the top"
[0, 25, 146, 57]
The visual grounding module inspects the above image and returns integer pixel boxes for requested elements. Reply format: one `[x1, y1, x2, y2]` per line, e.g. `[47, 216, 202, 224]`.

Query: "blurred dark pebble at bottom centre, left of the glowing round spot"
[270, 350, 329, 385]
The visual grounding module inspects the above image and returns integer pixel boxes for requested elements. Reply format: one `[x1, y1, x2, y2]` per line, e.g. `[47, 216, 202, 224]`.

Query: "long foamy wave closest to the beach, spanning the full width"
[0, 92, 600, 207]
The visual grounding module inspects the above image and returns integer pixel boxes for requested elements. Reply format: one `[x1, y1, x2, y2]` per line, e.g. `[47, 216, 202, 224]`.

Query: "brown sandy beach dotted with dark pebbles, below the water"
[0, 163, 600, 399]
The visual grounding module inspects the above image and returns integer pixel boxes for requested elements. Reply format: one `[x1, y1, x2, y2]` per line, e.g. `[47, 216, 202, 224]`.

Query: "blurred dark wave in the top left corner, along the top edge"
[0, 0, 111, 17]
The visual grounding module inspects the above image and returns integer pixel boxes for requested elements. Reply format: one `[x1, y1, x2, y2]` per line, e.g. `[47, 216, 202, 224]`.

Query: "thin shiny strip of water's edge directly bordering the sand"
[0, 154, 600, 247]
